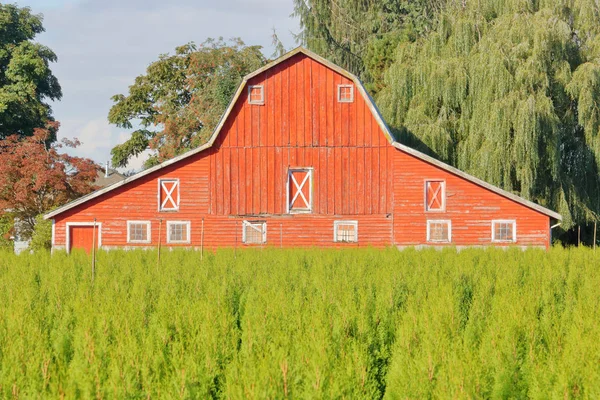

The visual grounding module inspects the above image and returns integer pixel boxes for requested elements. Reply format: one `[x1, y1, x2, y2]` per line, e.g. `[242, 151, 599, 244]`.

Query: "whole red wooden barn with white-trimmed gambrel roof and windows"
[45, 48, 561, 251]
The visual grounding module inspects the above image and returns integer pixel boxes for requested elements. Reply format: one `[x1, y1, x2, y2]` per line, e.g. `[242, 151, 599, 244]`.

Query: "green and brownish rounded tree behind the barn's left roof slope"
[108, 39, 266, 167]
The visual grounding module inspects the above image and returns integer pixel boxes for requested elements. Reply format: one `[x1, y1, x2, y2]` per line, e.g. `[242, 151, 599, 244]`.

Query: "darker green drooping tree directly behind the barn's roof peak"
[294, 0, 446, 93]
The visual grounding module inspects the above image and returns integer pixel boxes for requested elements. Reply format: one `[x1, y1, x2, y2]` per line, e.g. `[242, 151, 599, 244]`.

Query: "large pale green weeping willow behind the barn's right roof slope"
[377, 0, 600, 229]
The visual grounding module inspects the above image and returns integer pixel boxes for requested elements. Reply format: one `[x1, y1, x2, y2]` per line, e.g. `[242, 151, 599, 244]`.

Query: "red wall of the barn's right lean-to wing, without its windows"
[393, 151, 550, 247]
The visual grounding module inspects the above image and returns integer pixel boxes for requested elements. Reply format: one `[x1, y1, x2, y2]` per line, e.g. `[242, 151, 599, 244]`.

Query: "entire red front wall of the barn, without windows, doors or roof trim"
[54, 54, 549, 248]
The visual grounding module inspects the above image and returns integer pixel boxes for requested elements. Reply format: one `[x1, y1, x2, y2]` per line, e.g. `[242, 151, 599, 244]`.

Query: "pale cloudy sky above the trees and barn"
[16, 0, 299, 170]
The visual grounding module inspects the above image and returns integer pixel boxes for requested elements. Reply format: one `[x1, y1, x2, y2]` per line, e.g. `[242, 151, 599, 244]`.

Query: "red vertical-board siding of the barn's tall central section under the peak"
[210, 54, 392, 215]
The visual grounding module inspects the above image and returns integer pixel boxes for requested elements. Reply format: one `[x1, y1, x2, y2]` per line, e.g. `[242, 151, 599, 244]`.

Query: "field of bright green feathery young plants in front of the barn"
[0, 249, 600, 399]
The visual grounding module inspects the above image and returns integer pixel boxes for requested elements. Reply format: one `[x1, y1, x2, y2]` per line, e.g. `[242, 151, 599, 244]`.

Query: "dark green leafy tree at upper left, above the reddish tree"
[0, 4, 62, 139]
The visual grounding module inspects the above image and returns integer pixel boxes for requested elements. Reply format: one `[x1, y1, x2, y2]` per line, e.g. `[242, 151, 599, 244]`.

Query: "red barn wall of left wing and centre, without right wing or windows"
[55, 54, 395, 248]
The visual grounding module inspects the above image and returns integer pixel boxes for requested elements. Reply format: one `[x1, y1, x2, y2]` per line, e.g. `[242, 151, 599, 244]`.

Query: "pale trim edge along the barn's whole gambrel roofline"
[44, 46, 562, 221]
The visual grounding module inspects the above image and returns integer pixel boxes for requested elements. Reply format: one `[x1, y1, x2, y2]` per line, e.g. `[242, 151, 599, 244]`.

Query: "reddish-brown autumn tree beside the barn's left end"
[0, 123, 97, 235]
